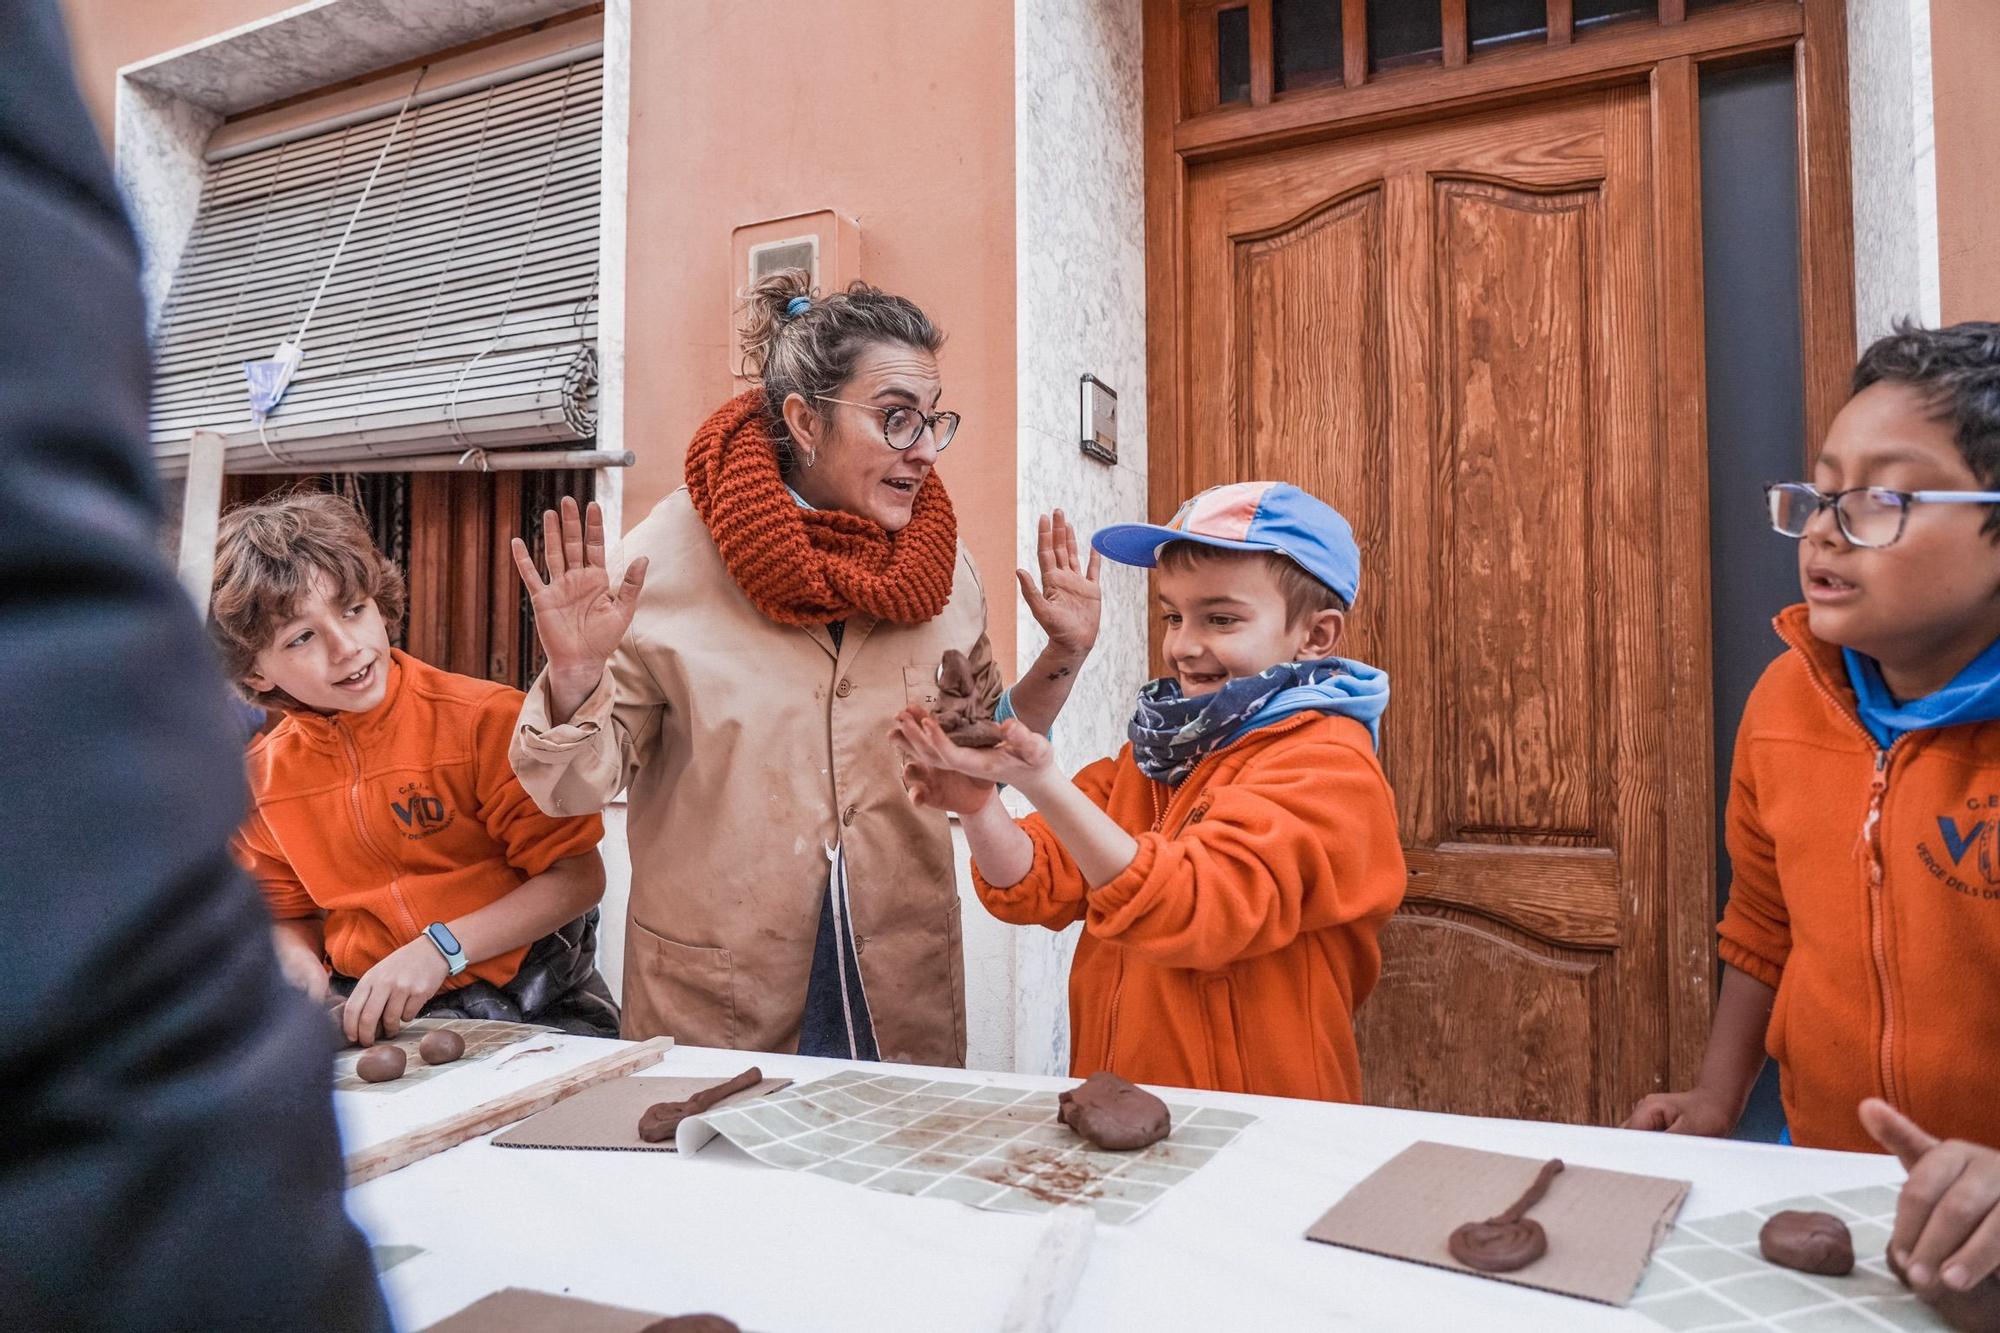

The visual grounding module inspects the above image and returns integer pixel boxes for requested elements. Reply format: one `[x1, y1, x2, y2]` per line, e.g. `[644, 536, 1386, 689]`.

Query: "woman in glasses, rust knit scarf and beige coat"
[500, 270, 1100, 1065]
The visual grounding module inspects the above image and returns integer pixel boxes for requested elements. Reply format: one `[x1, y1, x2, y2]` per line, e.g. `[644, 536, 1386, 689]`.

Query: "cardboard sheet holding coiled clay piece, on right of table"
[1306, 1143, 1688, 1305]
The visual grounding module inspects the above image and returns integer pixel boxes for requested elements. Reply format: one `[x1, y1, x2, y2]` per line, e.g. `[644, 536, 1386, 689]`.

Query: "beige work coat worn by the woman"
[512, 488, 1000, 1065]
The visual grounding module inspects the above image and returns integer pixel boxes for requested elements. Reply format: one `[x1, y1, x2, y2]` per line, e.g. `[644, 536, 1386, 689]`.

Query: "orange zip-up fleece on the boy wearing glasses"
[1720, 606, 2000, 1153]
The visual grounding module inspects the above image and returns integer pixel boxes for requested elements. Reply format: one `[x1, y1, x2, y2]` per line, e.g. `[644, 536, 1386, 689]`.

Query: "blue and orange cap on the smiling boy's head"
[1090, 482, 1362, 606]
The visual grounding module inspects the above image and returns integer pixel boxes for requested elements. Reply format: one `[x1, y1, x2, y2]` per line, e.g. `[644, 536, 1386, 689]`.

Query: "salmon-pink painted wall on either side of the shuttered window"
[64, 0, 1016, 662]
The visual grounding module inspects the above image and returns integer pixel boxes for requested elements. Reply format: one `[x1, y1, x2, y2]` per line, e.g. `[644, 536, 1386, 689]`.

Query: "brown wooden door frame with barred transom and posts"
[1142, 0, 1856, 1087]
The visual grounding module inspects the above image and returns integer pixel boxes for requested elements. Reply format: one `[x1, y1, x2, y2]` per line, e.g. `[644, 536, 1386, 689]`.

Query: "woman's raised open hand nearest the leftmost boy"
[514, 496, 646, 693]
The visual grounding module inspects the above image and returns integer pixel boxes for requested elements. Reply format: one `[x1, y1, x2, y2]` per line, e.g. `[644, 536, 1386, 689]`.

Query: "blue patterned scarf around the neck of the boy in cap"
[1126, 656, 1388, 787]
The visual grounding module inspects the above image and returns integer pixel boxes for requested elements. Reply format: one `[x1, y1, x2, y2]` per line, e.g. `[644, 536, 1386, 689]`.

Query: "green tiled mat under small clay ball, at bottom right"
[1632, 1185, 1944, 1333]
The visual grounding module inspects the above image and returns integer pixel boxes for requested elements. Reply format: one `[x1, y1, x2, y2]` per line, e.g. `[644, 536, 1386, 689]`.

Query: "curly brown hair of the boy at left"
[208, 490, 404, 709]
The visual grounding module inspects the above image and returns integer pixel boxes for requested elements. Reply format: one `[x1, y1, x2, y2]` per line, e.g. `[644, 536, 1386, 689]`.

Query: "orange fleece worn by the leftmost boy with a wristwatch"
[236, 652, 604, 991]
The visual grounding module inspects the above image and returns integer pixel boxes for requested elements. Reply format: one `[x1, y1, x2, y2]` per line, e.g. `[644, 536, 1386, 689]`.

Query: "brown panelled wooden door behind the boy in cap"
[1178, 86, 1710, 1123]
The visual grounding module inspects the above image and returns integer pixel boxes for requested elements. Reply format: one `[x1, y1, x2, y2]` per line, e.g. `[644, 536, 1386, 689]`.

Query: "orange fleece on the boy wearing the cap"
[974, 713, 1408, 1101]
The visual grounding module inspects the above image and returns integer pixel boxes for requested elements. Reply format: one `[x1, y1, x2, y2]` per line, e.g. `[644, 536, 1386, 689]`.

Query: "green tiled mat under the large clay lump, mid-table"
[680, 1071, 1256, 1223]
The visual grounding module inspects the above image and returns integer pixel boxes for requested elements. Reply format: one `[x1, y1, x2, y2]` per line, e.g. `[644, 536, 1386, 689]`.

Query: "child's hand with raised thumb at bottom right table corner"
[1860, 1097, 2000, 1293]
